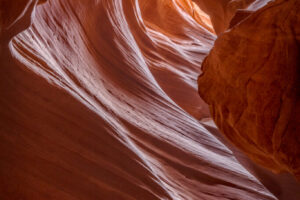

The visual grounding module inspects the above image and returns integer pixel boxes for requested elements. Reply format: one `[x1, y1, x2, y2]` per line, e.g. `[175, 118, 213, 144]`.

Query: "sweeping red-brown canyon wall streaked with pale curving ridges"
[0, 0, 297, 200]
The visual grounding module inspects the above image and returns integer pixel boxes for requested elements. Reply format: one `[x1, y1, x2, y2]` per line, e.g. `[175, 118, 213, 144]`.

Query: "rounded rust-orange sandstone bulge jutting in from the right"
[198, 0, 300, 179]
